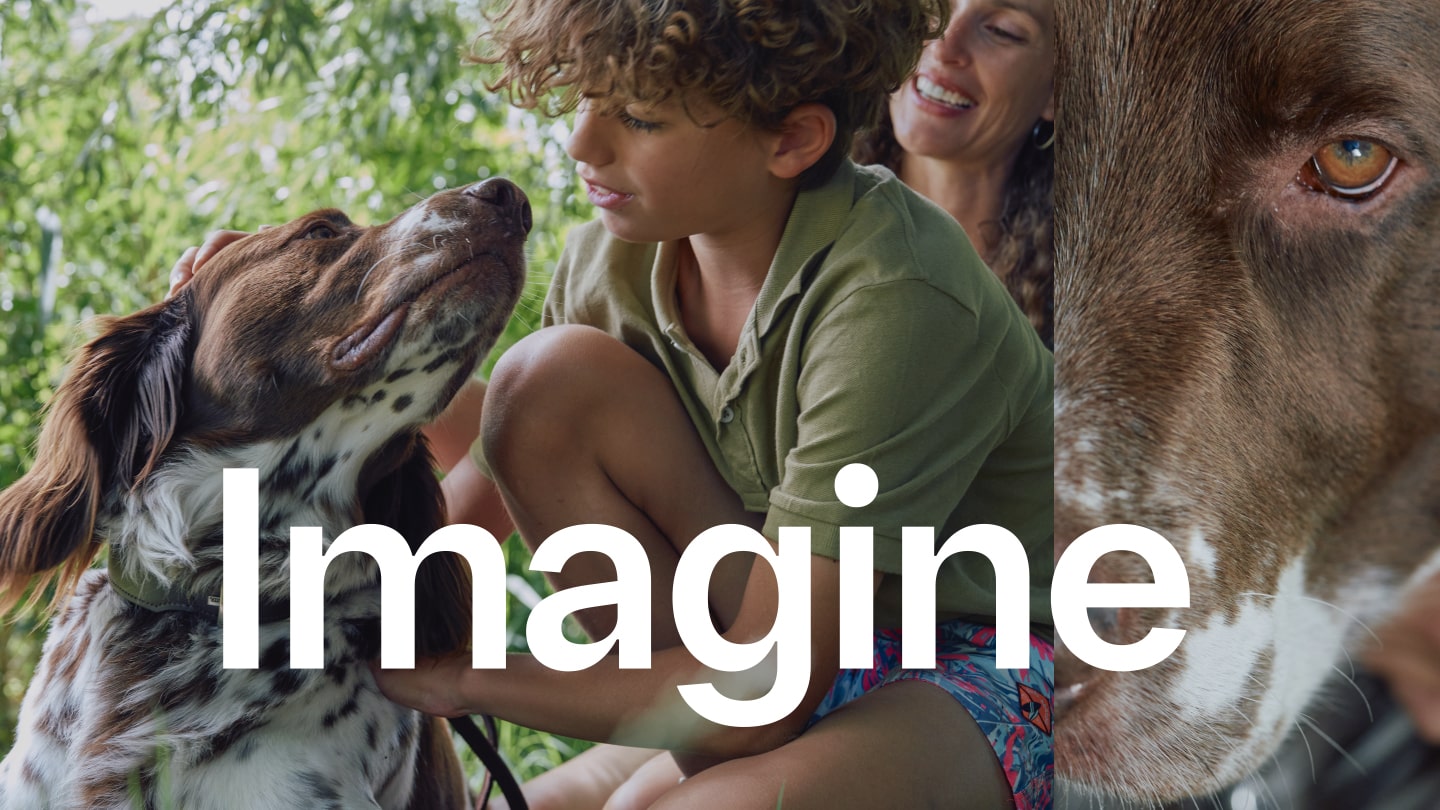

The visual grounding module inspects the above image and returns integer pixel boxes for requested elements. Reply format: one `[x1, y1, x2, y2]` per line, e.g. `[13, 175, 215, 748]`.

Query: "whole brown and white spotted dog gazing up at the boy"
[0, 179, 531, 810]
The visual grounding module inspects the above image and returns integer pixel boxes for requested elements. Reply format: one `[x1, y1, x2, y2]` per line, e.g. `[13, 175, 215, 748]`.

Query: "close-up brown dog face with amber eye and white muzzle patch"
[1056, 0, 1440, 803]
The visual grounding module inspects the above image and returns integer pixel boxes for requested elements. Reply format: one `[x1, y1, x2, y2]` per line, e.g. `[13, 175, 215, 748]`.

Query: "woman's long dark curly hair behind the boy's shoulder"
[852, 108, 1056, 346]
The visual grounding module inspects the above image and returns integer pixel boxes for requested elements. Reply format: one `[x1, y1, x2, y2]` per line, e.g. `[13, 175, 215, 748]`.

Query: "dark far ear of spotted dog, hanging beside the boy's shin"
[363, 435, 472, 656]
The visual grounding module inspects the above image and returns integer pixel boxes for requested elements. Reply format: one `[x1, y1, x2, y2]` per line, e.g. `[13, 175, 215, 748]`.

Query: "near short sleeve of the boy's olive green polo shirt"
[765, 280, 1014, 572]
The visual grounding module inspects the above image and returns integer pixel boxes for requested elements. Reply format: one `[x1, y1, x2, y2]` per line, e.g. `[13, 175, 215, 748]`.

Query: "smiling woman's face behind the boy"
[890, 0, 1056, 164]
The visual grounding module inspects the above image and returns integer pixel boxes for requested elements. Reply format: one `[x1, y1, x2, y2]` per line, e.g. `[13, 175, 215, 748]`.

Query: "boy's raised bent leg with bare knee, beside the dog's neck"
[481, 326, 763, 649]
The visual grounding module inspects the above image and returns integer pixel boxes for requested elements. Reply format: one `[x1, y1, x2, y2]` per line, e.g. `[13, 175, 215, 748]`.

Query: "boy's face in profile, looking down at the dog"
[566, 101, 792, 242]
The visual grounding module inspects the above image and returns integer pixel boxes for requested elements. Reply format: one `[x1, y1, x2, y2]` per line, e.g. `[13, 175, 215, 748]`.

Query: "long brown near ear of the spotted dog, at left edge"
[0, 291, 193, 615]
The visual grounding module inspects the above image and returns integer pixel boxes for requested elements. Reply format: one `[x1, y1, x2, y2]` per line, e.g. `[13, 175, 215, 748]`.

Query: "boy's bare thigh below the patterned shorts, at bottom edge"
[652, 680, 1014, 810]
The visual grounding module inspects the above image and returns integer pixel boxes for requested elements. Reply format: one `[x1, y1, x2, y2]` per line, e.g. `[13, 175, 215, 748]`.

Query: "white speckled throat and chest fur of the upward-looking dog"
[0, 368, 454, 809]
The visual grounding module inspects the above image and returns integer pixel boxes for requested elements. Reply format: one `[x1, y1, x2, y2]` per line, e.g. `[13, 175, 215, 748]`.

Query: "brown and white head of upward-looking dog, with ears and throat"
[0, 180, 531, 642]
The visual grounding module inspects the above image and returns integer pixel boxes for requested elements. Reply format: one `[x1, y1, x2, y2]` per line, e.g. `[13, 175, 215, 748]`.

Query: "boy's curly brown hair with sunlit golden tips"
[469, 0, 950, 186]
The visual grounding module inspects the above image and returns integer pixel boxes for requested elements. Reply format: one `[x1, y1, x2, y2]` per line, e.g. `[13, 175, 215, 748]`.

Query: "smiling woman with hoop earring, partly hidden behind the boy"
[854, 0, 1056, 346]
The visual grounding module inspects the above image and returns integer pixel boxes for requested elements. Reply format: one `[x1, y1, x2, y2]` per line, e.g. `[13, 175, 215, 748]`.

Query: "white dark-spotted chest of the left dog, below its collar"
[0, 571, 419, 809]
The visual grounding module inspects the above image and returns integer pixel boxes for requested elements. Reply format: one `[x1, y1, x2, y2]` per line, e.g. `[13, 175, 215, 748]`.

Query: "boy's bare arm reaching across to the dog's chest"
[376, 544, 880, 758]
